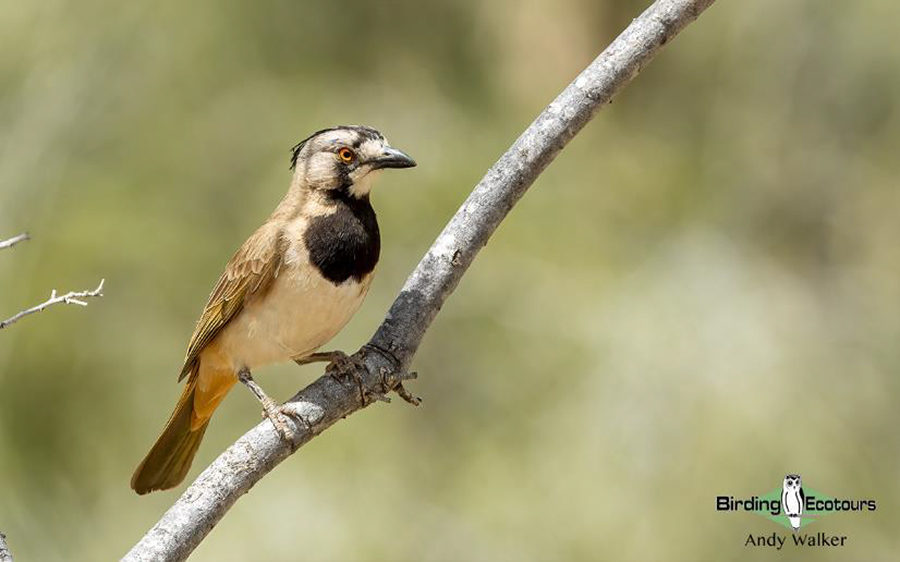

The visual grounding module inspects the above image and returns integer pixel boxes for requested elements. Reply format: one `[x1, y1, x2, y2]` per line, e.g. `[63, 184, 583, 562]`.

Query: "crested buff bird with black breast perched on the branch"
[131, 125, 416, 494]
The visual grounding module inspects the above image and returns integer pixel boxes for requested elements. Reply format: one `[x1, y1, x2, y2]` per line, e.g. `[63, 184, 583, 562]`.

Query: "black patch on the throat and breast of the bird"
[303, 190, 381, 284]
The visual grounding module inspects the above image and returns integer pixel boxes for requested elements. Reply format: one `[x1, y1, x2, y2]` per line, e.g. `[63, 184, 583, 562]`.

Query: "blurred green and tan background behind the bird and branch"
[0, 0, 900, 561]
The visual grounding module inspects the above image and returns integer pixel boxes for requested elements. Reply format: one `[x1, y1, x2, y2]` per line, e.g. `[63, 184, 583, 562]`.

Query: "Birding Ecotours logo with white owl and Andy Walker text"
[716, 474, 877, 550]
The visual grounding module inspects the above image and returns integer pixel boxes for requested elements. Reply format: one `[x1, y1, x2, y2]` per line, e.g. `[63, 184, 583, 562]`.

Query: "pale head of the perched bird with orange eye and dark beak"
[291, 125, 416, 199]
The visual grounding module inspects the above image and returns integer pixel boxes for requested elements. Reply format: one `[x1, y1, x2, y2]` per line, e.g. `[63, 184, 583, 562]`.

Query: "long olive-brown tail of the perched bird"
[131, 376, 211, 494]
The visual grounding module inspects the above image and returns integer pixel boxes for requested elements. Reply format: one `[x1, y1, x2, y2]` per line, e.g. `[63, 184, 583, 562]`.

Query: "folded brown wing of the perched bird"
[178, 224, 282, 381]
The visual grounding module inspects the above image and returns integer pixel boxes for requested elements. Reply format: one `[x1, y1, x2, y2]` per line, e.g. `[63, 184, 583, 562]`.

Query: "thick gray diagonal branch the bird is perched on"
[124, 0, 715, 561]
